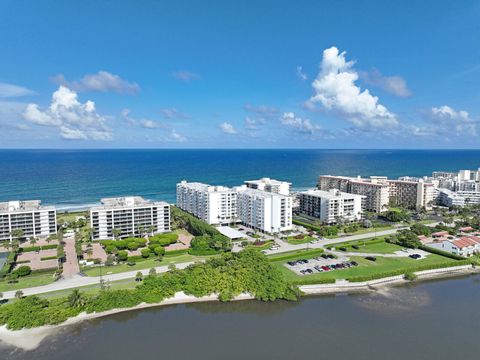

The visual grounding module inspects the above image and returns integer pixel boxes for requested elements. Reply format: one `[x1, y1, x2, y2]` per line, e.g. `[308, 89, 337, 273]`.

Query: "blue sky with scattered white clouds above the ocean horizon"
[0, 0, 480, 148]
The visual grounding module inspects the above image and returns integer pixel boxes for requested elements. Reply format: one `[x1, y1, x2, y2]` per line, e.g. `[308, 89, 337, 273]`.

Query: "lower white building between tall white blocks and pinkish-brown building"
[298, 189, 366, 224]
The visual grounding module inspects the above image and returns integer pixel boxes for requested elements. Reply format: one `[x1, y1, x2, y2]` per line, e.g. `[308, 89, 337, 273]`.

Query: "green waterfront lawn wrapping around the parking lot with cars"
[273, 250, 463, 285]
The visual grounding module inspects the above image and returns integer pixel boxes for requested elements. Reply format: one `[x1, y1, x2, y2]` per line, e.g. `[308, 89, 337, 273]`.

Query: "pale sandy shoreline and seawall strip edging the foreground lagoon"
[0, 265, 480, 351]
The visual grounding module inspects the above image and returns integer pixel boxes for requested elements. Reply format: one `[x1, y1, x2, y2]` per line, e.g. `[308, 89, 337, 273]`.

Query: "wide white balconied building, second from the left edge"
[90, 196, 170, 240]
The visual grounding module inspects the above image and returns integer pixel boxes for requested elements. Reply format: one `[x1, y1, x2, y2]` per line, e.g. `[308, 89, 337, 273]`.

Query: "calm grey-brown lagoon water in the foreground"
[0, 275, 480, 360]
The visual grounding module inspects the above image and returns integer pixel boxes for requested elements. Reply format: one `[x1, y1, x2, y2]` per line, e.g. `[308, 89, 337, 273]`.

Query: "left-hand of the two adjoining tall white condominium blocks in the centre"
[177, 181, 237, 225]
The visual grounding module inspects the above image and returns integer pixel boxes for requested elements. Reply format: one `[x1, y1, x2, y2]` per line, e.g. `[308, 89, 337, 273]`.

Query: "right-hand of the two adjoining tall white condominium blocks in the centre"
[235, 185, 293, 233]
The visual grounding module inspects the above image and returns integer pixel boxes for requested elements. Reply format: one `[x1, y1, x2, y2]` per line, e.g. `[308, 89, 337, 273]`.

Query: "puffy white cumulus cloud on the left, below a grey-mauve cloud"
[23, 86, 112, 140]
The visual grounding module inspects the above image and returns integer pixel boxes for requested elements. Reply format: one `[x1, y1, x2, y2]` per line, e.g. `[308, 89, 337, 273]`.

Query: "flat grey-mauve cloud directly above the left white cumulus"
[52, 70, 140, 95]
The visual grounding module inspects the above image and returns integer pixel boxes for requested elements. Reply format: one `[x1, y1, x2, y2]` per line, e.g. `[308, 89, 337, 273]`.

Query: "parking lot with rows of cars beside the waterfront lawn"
[284, 254, 358, 275]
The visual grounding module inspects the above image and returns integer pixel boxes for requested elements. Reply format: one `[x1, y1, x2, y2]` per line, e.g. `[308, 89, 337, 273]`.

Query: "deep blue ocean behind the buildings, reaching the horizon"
[0, 150, 480, 208]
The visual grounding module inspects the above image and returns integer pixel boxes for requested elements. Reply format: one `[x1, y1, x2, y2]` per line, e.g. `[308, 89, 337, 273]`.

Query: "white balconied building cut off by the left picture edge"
[0, 200, 57, 241]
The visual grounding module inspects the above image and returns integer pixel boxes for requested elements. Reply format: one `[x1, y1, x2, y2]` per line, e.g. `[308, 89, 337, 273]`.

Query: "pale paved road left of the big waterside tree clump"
[3, 261, 194, 299]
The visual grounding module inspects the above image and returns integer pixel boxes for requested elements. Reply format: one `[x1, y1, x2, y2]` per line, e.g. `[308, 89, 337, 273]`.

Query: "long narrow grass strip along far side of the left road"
[83, 254, 211, 276]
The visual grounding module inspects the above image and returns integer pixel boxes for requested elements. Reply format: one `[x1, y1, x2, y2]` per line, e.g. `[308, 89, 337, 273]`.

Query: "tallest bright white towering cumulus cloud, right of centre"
[306, 46, 399, 129]
